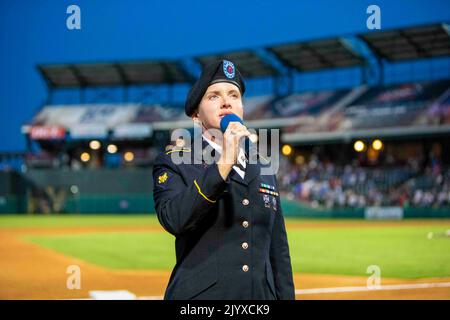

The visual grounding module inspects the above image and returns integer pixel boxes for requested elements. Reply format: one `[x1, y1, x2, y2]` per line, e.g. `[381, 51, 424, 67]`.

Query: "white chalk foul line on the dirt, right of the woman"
[295, 282, 450, 295]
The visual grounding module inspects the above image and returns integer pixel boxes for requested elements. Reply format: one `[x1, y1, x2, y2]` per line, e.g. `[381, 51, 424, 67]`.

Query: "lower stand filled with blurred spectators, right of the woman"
[278, 157, 450, 208]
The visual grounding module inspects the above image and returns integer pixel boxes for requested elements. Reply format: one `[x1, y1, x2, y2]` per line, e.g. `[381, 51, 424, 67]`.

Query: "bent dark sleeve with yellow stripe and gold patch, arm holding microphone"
[153, 154, 229, 236]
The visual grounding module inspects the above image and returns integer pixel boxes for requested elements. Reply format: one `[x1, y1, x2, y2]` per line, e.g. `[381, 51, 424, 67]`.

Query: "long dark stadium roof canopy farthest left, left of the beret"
[38, 61, 192, 88]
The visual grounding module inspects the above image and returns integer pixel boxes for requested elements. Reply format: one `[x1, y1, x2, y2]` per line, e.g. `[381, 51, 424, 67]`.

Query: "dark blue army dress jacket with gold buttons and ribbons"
[153, 142, 295, 300]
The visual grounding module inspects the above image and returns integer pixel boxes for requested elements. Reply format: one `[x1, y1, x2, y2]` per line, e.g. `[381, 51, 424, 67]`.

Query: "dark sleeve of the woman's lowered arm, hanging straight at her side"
[270, 191, 295, 300]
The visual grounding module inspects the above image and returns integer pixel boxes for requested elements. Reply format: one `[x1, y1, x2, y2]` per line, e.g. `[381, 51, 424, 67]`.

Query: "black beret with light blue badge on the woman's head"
[184, 60, 245, 117]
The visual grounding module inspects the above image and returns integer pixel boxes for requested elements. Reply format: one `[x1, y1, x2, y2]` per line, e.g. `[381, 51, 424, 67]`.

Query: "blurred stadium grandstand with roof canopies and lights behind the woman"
[0, 23, 450, 216]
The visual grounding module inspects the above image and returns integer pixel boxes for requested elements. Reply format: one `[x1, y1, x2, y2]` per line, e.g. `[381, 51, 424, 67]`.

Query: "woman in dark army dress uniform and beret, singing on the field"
[153, 60, 295, 300]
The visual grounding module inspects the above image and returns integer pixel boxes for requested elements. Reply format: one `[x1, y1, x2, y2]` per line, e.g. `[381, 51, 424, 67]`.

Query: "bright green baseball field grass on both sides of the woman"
[0, 215, 450, 279]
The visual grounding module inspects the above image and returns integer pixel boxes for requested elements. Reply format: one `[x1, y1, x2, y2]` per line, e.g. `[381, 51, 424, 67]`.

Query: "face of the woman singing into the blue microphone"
[192, 82, 244, 129]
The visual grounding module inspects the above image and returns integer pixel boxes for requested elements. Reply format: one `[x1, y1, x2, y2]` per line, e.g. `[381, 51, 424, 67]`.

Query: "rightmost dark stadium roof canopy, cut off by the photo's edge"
[359, 23, 450, 62]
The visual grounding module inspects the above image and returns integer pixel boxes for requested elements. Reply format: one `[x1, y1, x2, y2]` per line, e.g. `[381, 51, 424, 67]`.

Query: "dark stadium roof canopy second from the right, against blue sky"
[267, 38, 364, 71]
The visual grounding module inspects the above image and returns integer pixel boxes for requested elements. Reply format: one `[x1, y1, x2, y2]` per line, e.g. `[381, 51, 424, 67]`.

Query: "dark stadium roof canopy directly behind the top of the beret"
[195, 50, 278, 78]
